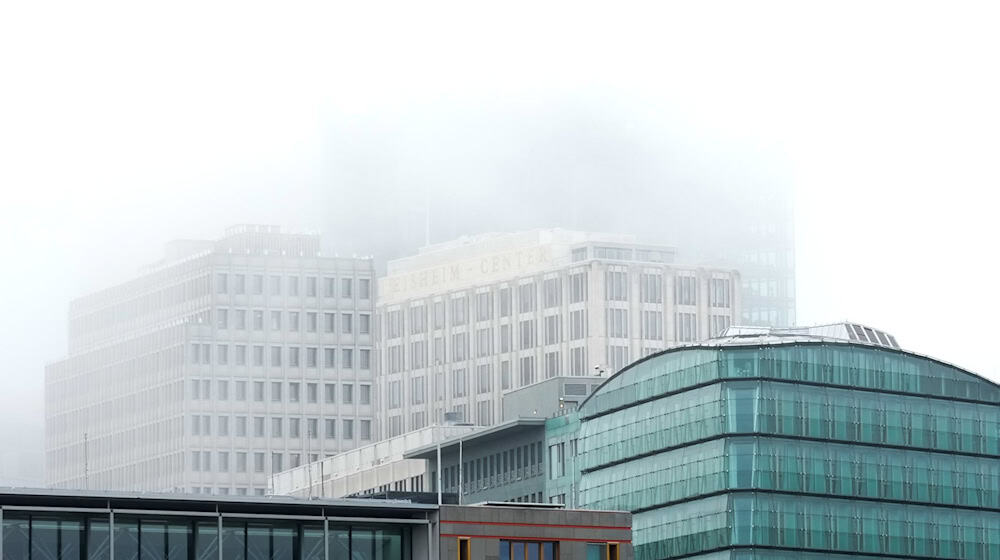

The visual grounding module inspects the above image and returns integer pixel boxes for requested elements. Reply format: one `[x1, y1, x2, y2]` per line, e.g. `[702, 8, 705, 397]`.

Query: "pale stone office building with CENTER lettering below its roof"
[377, 230, 740, 437]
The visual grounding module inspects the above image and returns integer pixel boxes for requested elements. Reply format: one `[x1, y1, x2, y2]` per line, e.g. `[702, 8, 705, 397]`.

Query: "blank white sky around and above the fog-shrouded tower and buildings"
[0, 1, 1000, 468]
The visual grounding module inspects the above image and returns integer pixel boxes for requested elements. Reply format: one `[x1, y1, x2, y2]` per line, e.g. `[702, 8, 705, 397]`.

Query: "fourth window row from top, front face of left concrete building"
[190, 379, 372, 405]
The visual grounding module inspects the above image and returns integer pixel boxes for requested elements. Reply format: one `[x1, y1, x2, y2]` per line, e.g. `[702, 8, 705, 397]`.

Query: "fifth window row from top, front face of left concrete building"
[190, 414, 371, 440]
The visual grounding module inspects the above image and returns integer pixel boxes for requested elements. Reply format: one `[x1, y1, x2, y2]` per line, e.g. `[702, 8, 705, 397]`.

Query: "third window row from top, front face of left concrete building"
[189, 342, 372, 370]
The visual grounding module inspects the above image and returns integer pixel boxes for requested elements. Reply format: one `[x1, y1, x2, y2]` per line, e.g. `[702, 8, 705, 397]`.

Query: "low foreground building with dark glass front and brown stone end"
[0, 490, 632, 560]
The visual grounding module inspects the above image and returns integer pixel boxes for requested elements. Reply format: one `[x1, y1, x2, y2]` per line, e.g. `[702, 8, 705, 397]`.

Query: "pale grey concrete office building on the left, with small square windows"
[45, 226, 375, 494]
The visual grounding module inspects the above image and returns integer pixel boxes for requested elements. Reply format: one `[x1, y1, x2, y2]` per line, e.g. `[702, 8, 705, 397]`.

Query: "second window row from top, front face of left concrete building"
[209, 307, 372, 335]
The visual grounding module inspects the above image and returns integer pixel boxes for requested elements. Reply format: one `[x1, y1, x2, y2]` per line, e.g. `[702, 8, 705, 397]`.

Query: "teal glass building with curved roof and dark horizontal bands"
[576, 325, 1000, 560]
